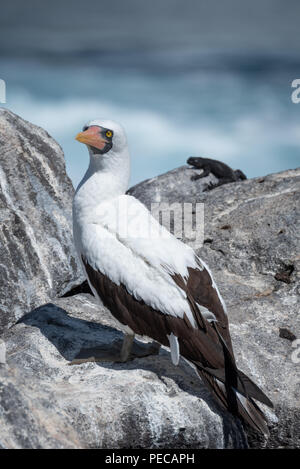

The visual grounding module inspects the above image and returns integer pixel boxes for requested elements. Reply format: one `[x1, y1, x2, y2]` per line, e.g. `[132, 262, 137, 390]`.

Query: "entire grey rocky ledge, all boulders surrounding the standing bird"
[0, 110, 300, 448]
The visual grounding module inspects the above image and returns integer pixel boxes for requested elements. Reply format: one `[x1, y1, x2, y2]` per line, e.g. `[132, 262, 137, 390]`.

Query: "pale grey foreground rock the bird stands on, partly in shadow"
[0, 294, 247, 448]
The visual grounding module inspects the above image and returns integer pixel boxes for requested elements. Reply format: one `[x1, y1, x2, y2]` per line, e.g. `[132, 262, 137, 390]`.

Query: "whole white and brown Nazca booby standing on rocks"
[73, 120, 272, 434]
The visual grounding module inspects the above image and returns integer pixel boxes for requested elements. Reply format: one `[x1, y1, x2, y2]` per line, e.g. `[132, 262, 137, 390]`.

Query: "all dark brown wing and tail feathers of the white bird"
[82, 258, 272, 433]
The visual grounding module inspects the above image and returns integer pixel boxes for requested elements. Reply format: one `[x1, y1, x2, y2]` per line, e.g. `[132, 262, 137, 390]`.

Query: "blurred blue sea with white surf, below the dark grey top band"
[0, 49, 300, 186]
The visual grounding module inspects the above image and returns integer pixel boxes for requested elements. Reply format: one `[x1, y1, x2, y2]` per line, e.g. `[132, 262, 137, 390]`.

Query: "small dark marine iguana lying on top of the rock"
[187, 156, 247, 191]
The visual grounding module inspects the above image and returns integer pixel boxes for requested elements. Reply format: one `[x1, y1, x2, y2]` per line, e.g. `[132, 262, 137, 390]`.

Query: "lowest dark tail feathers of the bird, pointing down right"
[197, 367, 269, 436]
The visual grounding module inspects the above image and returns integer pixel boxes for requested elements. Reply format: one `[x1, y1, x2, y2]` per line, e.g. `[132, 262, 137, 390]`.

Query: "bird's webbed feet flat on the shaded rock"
[69, 340, 160, 365]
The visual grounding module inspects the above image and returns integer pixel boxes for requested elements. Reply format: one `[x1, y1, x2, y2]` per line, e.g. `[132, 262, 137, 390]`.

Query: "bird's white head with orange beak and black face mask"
[76, 119, 130, 196]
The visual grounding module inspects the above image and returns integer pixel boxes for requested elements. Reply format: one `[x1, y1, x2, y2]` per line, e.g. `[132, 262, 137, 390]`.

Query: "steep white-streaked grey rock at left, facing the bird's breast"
[0, 108, 82, 331]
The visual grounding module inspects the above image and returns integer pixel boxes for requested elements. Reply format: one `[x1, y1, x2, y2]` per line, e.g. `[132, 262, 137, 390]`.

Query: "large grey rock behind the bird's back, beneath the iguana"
[131, 168, 300, 448]
